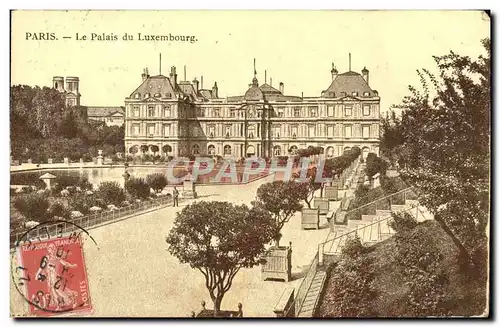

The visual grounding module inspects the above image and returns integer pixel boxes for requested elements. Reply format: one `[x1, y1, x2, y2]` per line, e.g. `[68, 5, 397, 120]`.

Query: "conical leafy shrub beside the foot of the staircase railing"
[322, 236, 377, 317]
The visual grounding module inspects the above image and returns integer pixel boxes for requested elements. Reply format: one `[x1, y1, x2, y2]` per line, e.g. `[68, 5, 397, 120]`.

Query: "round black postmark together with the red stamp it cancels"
[11, 220, 97, 317]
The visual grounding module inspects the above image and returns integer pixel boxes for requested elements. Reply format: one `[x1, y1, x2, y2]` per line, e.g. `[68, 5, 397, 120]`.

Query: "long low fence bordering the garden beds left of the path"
[10, 197, 173, 248]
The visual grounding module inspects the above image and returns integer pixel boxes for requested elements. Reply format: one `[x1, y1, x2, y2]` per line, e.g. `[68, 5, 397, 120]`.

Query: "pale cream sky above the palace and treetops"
[11, 10, 490, 111]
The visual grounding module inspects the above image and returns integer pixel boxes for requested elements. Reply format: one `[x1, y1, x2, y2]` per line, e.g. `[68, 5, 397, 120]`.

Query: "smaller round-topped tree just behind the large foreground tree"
[253, 181, 308, 246]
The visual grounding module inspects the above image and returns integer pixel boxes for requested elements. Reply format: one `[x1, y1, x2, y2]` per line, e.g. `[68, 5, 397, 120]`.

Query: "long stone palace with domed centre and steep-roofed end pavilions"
[125, 60, 380, 158]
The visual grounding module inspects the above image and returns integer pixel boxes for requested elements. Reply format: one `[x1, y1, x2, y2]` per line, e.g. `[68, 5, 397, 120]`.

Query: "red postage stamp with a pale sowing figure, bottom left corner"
[17, 236, 92, 317]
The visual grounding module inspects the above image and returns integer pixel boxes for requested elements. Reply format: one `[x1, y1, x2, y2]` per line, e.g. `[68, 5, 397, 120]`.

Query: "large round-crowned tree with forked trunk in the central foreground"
[166, 201, 274, 316]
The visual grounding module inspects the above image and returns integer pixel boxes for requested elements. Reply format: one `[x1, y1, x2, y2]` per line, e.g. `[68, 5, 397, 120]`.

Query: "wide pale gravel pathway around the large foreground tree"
[11, 177, 328, 317]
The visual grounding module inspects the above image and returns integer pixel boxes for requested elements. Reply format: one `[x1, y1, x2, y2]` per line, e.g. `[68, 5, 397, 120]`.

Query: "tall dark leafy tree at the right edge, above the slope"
[388, 39, 491, 268]
